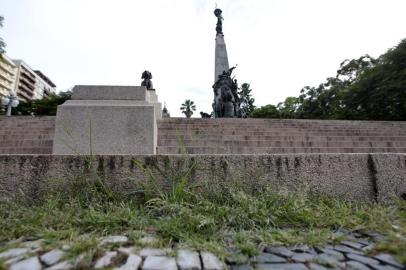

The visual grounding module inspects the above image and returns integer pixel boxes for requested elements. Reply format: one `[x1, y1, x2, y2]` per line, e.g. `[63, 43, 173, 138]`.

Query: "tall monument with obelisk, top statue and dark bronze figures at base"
[213, 8, 241, 118]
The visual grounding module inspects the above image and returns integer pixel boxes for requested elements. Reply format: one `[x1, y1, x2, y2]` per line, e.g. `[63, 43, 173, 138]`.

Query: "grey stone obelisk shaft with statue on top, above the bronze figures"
[214, 8, 229, 82]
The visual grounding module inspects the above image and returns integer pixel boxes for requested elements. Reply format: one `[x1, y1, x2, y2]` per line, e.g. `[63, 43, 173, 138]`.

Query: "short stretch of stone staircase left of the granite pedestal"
[0, 116, 55, 155]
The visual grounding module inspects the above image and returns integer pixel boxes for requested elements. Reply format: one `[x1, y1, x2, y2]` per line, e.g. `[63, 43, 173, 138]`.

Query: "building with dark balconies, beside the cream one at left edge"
[13, 60, 56, 101]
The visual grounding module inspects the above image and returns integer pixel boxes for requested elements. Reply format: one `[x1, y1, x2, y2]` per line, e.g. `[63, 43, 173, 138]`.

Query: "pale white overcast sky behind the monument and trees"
[0, 0, 406, 117]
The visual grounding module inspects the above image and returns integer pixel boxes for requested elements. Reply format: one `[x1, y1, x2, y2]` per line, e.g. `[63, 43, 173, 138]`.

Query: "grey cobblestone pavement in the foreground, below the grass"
[0, 232, 406, 270]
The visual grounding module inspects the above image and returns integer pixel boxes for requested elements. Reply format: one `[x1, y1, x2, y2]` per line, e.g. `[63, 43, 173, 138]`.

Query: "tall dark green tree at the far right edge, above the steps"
[343, 39, 406, 121]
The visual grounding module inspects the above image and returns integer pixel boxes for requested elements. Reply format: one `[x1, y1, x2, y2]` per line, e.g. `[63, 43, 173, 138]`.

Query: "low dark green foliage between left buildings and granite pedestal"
[13, 91, 72, 115]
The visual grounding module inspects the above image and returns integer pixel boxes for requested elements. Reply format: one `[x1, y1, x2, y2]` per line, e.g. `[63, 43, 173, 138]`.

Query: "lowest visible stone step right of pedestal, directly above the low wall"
[157, 146, 406, 154]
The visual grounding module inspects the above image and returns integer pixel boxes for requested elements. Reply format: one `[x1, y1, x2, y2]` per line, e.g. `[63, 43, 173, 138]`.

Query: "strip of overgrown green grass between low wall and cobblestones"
[0, 172, 406, 263]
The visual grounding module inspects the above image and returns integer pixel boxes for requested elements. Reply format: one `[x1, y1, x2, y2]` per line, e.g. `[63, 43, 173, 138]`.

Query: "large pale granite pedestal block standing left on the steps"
[52, 85, 161, 155]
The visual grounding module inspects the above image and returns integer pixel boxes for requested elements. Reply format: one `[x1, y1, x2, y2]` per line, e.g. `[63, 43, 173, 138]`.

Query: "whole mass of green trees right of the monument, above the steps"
[253, 39, 406, 121]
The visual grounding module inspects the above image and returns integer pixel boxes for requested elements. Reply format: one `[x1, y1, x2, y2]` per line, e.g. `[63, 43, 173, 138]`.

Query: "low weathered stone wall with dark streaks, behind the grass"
[0, 154, 406, 201]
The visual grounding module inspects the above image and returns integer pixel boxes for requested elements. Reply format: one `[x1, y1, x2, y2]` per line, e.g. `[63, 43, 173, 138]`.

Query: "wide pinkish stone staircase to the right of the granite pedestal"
[157, 118, 406, 154]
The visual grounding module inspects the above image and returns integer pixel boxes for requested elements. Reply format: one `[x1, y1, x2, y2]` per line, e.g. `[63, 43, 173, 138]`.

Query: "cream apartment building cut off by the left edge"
[0, 54, 18, 98]
